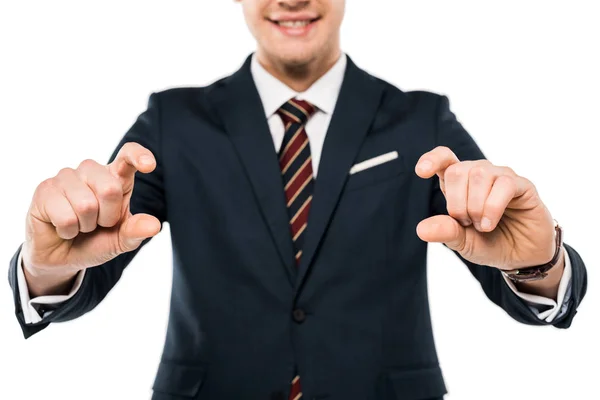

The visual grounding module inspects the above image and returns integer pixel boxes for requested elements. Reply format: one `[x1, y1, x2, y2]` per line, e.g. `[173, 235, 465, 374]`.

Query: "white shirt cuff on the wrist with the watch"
[502, 246, 572, 323]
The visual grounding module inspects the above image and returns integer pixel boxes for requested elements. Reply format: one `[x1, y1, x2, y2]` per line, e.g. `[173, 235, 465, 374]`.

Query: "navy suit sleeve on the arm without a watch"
[8, 94, 167, 338]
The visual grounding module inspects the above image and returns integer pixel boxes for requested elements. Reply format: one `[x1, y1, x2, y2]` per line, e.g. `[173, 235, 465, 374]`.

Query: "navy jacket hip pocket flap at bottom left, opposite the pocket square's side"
[152, 362, 206, 399]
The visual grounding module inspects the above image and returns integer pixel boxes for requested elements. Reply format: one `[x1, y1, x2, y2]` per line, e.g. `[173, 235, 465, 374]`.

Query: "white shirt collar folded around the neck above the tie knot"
[250, 53, 347, 118]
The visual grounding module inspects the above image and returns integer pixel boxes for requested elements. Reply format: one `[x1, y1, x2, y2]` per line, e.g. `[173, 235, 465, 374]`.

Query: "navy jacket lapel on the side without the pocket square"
[211, 57, 297, 285]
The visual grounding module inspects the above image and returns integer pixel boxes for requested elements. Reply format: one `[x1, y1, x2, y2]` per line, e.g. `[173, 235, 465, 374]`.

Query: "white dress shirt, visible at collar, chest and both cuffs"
[17, 54, 571, 324]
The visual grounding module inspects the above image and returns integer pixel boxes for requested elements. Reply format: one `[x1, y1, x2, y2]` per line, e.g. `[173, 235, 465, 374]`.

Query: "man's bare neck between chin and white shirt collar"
[256, 48, 342, 92]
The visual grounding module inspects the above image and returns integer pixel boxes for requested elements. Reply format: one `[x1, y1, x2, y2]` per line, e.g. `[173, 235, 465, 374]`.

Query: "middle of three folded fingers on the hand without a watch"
[54, 168, 99, 233]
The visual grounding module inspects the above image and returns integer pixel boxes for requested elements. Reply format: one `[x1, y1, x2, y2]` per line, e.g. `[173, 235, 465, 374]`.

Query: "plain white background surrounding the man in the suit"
[0, 0, 600, 400]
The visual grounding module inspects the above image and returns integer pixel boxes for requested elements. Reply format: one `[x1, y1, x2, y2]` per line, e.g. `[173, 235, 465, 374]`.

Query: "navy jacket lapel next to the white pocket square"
[296, 57, 383, 294]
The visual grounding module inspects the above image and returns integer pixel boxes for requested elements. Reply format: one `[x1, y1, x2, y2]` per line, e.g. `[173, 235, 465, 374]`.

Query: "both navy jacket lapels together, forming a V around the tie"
[210, 57, 383, 293]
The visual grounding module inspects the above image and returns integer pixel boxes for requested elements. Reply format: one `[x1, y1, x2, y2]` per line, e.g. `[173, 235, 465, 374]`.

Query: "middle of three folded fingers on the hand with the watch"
[467, 163, 502, 231]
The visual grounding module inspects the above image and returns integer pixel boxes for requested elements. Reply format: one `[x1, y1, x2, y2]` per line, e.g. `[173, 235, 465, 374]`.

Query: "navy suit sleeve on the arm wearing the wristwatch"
[431, 96, 587, 328]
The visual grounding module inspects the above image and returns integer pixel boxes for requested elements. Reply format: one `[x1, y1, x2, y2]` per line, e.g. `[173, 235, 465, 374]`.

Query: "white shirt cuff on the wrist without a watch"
[17, 248, 85, 324]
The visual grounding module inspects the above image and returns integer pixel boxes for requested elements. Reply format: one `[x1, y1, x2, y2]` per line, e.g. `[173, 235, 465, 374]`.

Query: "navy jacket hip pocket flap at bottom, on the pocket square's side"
[388, 367, 447, 400]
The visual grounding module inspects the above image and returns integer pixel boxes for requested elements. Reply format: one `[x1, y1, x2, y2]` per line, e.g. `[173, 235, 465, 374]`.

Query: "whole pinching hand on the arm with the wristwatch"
[415, 146, 556, 269]
